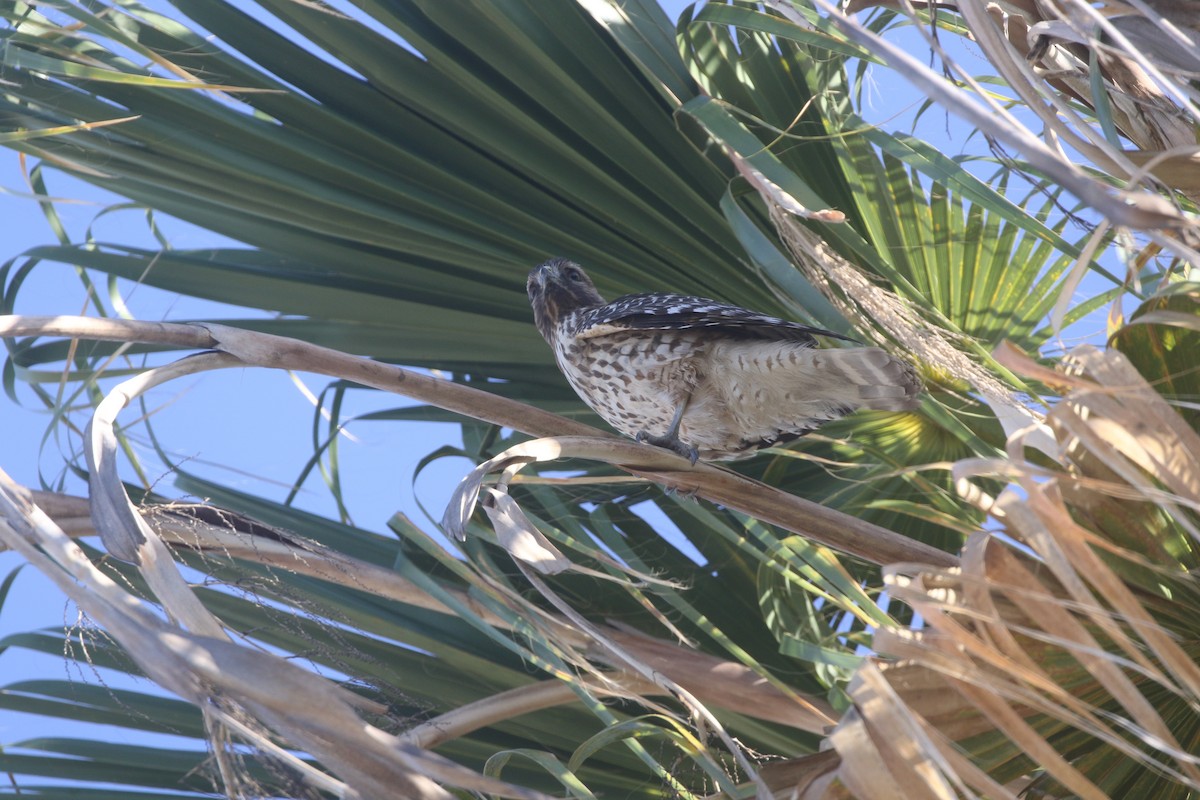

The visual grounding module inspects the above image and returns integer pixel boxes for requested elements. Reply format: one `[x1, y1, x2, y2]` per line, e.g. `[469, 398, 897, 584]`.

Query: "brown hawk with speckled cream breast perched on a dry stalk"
[527, 258, 920, 463]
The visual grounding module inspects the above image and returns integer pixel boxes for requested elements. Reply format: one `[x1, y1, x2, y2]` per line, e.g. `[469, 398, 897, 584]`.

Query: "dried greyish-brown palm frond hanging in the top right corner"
[847, 0, 1200, 200]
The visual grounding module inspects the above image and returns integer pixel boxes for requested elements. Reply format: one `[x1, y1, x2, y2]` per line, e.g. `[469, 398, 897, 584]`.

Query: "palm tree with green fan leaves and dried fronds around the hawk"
[0, 0, 1200, 798]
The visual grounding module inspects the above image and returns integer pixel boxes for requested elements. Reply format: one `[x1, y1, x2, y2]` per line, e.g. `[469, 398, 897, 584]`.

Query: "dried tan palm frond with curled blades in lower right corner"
[800, 347, 1200, 800]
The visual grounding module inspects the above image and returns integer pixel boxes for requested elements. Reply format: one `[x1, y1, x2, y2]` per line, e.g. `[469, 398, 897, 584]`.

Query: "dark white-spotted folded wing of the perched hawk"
[571, 291, 857, 347]
